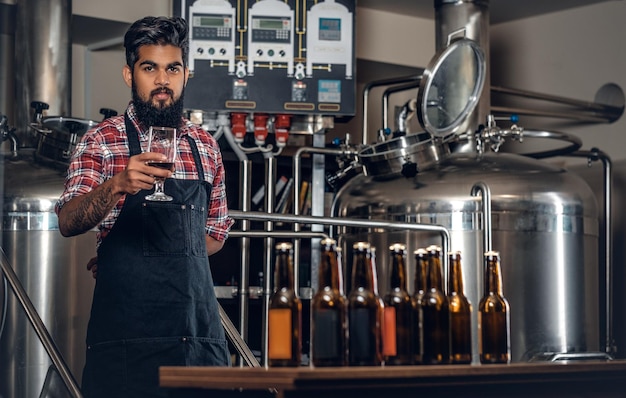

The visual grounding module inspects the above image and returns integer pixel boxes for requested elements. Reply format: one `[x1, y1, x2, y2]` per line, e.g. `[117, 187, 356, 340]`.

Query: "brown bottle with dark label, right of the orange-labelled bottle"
[311, 238, 348, 366]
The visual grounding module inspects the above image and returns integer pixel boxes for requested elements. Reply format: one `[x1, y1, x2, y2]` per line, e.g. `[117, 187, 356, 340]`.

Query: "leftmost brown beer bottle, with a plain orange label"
[268, 242, 302, 366]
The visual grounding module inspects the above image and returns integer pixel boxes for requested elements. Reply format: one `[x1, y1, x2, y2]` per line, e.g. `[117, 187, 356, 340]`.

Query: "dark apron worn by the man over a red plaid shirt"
[82, 115, 230, 398]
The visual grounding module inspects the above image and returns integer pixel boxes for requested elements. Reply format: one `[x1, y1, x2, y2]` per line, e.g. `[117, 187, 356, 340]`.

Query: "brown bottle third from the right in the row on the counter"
[422, 246, 450, 365]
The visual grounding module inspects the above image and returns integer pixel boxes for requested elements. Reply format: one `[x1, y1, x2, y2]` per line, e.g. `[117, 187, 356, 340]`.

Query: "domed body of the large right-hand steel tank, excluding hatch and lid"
[332, 150, 600, 362]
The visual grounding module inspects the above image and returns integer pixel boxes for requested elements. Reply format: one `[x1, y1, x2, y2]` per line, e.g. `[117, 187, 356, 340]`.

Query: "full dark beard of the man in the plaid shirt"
[132, 83, 185, 128]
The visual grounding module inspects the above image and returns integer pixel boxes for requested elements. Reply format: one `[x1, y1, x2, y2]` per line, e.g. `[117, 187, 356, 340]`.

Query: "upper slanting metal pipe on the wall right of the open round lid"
[491, 86, 624, 123]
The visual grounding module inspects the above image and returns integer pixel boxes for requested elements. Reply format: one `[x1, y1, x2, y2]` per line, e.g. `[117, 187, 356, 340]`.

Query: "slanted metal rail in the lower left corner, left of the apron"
[0, 248, 83, 398]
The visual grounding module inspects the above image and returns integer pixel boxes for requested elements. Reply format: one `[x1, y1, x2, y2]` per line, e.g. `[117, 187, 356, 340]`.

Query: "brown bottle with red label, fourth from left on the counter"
[382, 243, 413, 365]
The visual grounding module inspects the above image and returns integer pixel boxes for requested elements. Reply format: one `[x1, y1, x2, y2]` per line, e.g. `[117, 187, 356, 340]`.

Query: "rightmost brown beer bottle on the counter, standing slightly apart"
[478, 251, 511, 364]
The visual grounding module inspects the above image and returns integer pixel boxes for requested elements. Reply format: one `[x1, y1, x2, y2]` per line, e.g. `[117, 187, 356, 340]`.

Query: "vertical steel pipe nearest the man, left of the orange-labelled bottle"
[238, 160, 252, 366]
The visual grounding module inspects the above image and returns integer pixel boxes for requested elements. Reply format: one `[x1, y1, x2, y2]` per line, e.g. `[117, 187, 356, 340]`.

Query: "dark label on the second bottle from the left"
[313, 309, 342, 359]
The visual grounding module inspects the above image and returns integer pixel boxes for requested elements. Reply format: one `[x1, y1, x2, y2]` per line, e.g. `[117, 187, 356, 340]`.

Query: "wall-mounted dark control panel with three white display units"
[174, 0, 356, 116]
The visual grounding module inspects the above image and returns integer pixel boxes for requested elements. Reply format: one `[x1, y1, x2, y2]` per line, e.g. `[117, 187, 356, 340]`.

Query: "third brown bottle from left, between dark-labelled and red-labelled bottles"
[348, 242, 382, 366]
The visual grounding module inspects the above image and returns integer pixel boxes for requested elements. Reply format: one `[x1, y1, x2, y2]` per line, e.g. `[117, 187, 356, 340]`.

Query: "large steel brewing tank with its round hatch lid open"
[332, 35, 600, 362]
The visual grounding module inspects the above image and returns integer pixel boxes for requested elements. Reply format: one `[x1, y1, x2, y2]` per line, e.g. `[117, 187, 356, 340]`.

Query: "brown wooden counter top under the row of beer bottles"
[160, 360, 626, 398]
